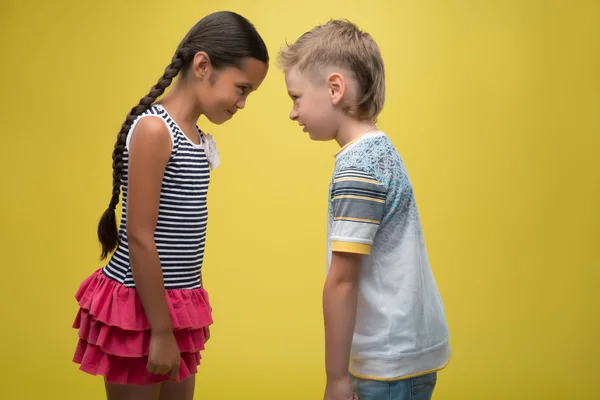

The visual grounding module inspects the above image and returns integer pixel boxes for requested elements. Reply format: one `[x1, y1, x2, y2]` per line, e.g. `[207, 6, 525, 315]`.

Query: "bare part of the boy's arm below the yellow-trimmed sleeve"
[323, 252, 362, 381]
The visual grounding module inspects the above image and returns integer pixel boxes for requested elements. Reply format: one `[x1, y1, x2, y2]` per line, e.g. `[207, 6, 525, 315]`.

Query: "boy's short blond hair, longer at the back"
[277, 19, 385, 121]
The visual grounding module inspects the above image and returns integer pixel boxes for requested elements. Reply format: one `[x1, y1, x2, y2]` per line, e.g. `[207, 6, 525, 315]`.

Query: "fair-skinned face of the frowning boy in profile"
[285, 68, 339, 140]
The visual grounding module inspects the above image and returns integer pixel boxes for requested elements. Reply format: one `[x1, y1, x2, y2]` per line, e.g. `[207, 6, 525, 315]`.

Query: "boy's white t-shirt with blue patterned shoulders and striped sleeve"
[327, 132, 450, 380]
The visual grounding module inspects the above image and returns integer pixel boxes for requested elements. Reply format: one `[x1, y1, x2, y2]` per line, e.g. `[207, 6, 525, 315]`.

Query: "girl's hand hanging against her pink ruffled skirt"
[147, 331, 181, 379]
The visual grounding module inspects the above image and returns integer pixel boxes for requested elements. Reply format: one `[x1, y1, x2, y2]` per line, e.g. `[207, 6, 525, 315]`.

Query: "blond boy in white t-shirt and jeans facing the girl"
[278, 20, 450, 400]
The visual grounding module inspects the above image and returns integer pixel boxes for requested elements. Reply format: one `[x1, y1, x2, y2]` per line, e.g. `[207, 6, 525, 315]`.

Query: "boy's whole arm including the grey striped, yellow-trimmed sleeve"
[323, 169, 387, 381]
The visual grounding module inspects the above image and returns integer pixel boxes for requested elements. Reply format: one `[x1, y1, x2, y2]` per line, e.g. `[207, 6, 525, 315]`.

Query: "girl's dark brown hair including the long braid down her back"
[98, 11, 269, 259]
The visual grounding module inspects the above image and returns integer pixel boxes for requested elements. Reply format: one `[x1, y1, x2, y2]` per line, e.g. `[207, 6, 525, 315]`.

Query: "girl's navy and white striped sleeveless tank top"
[103, 105, 210, 289]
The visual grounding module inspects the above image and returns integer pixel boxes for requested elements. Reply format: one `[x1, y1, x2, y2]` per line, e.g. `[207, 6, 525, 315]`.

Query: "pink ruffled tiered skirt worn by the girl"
[73, 269, 213, 386]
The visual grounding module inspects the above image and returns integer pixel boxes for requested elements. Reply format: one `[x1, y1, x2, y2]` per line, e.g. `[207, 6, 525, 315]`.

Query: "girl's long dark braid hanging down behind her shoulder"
[98, 48, 186, 259]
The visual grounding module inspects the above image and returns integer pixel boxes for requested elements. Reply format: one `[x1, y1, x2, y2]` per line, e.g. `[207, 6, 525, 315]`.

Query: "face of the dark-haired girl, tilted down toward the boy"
[193, 53, 268, 125]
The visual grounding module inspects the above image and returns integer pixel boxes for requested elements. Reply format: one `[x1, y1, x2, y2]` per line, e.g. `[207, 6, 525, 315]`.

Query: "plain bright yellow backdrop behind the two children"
[0, 0, 600, 400]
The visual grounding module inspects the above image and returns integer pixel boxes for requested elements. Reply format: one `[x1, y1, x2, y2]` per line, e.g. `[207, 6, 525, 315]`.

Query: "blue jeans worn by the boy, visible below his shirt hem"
[350, 372, 437, 400]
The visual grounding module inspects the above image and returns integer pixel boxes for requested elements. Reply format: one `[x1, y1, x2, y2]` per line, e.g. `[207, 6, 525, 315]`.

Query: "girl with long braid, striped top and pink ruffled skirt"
[74, 12, 269, 400]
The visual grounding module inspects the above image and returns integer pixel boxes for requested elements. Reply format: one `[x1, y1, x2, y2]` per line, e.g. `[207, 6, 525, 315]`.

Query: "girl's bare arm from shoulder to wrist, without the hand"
[127, 117, 173, 335]
